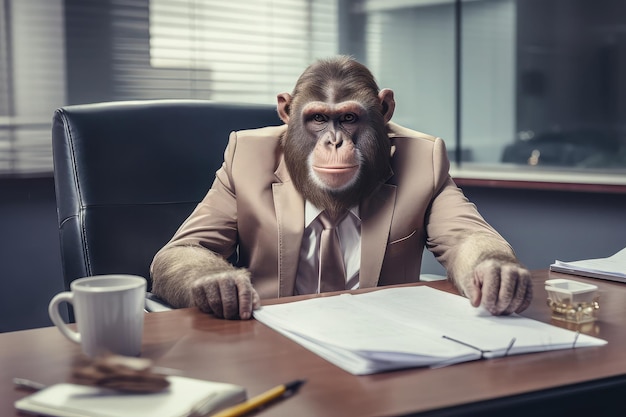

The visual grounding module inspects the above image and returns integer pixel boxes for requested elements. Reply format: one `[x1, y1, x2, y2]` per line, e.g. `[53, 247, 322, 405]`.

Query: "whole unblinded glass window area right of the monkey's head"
[358, 0, 626, 175]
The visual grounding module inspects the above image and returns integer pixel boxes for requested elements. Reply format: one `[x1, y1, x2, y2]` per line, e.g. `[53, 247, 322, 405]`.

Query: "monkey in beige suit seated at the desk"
[151, 56, 532, 320]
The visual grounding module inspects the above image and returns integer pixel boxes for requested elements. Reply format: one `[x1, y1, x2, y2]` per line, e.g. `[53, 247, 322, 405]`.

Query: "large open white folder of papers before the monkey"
[254, 286, 607, 375]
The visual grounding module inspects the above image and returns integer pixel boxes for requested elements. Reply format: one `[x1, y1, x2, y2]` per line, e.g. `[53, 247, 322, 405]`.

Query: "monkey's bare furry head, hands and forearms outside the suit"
[151, 56, 532, 319]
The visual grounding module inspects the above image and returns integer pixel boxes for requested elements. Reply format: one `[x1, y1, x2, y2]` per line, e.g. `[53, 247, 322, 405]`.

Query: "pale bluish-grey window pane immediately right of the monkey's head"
[364, 1, 456, 151]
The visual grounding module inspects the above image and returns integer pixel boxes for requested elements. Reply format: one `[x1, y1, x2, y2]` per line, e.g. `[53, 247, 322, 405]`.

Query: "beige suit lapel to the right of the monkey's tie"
[359, 184, 396, 288]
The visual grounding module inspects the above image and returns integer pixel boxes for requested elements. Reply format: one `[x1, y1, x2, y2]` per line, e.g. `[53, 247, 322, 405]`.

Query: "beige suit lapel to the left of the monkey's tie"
[272, 159, 304, 297]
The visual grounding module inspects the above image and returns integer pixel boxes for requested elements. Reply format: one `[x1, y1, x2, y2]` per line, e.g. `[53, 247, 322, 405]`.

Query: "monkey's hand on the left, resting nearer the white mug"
[191, 269, 261, 320]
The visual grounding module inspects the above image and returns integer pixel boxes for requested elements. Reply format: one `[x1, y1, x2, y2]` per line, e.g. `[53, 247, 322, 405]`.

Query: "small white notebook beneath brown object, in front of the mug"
[15, 376, 247, 417]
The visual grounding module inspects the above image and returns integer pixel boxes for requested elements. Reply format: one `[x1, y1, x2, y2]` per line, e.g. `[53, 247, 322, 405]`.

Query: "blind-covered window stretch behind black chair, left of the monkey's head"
[0, 0, 338, 175]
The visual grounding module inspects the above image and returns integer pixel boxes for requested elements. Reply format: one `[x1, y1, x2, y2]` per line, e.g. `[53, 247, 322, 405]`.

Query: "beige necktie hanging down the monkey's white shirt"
[319, 211, 348, 292]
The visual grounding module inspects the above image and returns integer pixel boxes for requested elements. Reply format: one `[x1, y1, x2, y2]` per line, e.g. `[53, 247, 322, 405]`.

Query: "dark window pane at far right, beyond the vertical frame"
[510, 0, 626, 170]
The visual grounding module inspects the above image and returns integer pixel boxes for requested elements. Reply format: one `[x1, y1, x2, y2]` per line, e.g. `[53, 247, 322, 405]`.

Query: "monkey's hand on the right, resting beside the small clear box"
[459, 258, 533, 315]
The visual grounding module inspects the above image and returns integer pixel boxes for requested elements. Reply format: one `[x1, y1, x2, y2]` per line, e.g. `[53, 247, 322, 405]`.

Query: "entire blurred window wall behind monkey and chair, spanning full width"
[0, 0, 626, 182]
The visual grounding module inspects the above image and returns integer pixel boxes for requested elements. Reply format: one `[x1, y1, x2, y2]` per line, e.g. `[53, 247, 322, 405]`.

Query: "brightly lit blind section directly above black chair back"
[113, 0, 338, 103]
